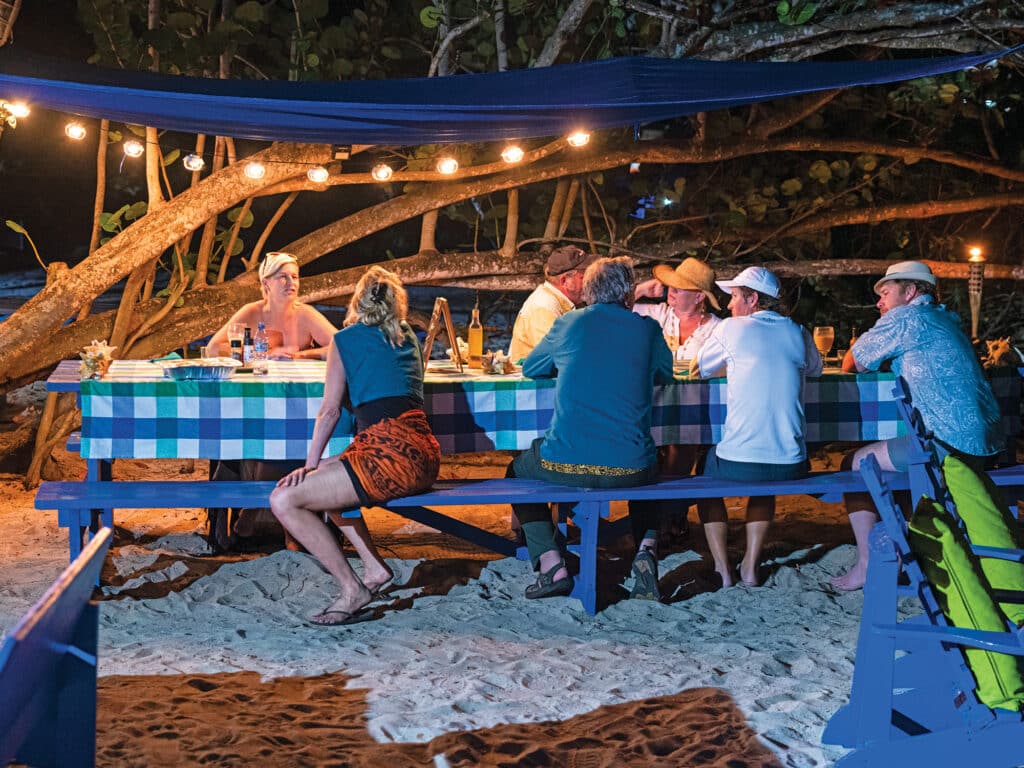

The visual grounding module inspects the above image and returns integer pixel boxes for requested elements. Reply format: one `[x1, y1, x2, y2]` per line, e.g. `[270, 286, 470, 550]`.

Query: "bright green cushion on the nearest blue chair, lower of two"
[907, 498, 1024, 710]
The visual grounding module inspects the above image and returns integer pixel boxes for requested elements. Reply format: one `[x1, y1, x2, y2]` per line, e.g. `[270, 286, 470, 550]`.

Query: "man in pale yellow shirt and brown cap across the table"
[509, 246, 597, 361]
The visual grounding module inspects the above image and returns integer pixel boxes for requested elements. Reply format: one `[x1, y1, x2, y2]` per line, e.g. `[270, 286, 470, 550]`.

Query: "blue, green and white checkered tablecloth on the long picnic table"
[72, 360, 1021, 460]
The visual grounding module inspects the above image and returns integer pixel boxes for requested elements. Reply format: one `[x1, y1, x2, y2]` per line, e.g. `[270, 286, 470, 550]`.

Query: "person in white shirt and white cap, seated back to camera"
[693, 266, 821, 587]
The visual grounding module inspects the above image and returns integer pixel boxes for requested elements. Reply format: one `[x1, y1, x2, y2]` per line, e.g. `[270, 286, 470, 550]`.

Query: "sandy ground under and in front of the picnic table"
[0, 454, 861, 768]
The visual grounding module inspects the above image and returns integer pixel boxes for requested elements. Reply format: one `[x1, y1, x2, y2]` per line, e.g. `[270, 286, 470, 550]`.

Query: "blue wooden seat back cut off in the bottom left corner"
[0, 528, 112, 768]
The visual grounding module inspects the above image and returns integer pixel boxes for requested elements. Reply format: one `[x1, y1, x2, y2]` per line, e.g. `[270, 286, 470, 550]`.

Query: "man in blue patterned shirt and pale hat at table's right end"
[831, 261, 1004, 590]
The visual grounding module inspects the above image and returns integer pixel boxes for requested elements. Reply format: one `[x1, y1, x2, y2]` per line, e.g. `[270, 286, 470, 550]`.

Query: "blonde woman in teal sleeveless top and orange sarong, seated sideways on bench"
[270, 266, 440, 626]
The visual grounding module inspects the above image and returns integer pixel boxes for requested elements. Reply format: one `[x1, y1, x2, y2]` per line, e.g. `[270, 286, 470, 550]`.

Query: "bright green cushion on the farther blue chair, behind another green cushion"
[942, 456, 1024, 627]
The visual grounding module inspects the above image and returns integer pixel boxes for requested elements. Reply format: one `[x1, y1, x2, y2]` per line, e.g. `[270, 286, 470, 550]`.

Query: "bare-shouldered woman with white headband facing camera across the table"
[209, 251, 338, 359]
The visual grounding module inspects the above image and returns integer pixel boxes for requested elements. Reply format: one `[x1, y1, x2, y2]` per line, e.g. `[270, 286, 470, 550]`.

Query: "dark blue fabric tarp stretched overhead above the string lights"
[0, 45, 1024, 145]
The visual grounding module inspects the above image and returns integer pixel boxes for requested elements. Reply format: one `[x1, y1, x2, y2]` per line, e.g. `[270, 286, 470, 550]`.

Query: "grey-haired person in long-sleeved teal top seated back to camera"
[509, 257, 673, 598]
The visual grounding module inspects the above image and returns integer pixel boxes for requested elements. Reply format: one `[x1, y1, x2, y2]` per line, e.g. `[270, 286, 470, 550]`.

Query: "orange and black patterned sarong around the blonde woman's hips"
[341, 409, 441, 504]
